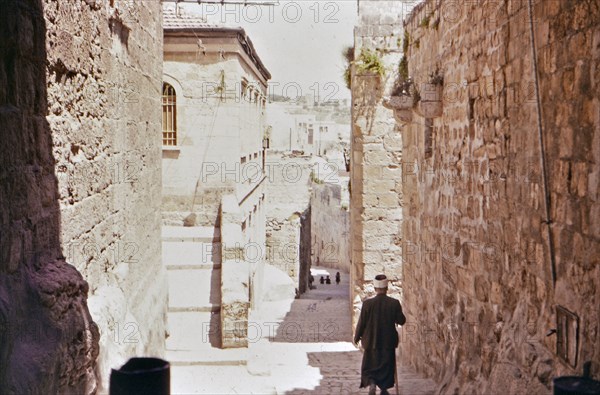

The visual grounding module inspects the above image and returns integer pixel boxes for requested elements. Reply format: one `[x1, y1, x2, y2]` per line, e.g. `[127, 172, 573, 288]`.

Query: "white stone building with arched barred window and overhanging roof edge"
[162, 8, 271, 347]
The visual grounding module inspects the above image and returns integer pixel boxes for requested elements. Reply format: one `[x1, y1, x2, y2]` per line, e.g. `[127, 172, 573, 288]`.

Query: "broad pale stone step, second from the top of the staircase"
[162, 241, 221, 270]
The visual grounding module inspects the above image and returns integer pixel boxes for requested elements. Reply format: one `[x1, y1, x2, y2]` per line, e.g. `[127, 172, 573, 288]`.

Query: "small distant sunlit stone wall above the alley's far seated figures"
[310, 183, 350, 272]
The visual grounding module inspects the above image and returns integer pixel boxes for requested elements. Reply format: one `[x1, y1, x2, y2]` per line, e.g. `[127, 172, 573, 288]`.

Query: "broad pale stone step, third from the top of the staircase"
[167, 268, 221, 312]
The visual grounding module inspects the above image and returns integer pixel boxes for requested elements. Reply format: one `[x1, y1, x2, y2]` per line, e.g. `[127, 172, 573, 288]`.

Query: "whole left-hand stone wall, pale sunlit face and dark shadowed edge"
[0, 0, 166, 393]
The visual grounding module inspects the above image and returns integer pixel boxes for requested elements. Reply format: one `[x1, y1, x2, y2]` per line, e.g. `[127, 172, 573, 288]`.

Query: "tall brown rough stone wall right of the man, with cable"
[396, 0, 600, 393]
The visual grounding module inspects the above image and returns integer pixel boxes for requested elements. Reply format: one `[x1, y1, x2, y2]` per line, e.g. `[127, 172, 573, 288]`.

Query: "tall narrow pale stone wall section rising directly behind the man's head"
[350, 1, 406, 325]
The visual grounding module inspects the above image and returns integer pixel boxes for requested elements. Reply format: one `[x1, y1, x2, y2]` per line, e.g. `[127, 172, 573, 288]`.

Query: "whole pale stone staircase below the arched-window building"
[162, 226, 247, 367]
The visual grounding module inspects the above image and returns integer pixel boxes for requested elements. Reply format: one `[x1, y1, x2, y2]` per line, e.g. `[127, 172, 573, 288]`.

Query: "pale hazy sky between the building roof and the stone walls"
[182, 0, 357, 101]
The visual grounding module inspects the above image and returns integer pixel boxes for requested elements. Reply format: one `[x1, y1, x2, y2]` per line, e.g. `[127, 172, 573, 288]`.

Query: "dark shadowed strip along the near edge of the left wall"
[0, 0, 99, 394]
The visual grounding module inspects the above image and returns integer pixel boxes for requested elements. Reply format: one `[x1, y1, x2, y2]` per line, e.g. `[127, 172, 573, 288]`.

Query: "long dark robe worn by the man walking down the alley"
[354, 294, 406, 389]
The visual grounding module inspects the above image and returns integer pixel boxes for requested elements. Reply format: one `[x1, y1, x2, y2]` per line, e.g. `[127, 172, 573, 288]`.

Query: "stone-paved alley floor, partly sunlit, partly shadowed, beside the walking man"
[167, 262, 435, 395]
